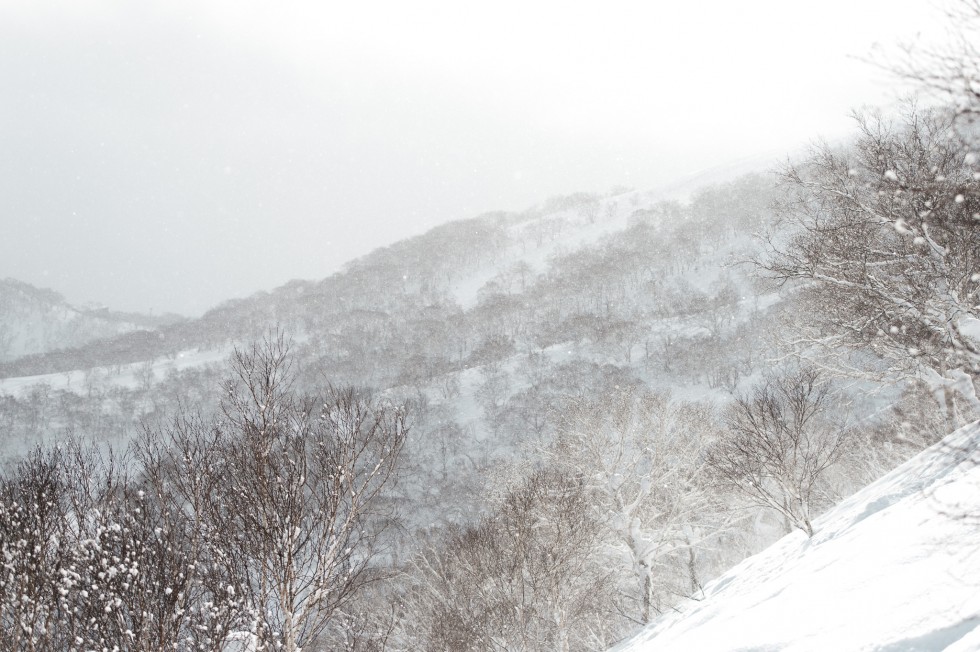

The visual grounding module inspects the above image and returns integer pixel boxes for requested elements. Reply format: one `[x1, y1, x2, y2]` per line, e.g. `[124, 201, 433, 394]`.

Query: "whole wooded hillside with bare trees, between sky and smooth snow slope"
[0, 34, 980, 652]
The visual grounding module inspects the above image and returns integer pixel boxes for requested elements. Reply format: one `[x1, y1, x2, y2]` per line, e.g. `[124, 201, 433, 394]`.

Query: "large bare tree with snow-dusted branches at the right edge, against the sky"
[759, 106, 980, 422]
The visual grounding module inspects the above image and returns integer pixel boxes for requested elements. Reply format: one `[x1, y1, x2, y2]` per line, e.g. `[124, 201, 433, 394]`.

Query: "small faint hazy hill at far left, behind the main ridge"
[0, 278, 181, 362]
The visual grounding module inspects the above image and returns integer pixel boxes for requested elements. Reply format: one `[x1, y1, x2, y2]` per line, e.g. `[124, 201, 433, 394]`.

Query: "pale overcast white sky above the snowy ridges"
[0, 0, 939, 314]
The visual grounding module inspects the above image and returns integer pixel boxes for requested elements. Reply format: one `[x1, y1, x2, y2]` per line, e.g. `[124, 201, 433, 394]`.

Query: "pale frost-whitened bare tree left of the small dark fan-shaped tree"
[546, 388, 731, 623]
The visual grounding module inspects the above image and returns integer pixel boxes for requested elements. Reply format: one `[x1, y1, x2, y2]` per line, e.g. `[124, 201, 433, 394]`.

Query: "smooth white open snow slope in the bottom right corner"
[614, 422, 980, 652]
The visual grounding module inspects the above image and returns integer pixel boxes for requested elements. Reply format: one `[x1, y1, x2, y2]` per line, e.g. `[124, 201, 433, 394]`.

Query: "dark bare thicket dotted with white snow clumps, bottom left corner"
[0, 440, 241, 652]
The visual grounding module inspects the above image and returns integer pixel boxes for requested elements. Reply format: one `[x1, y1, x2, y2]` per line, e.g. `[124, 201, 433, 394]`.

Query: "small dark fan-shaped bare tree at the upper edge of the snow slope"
[706, 368, 849, 537]
